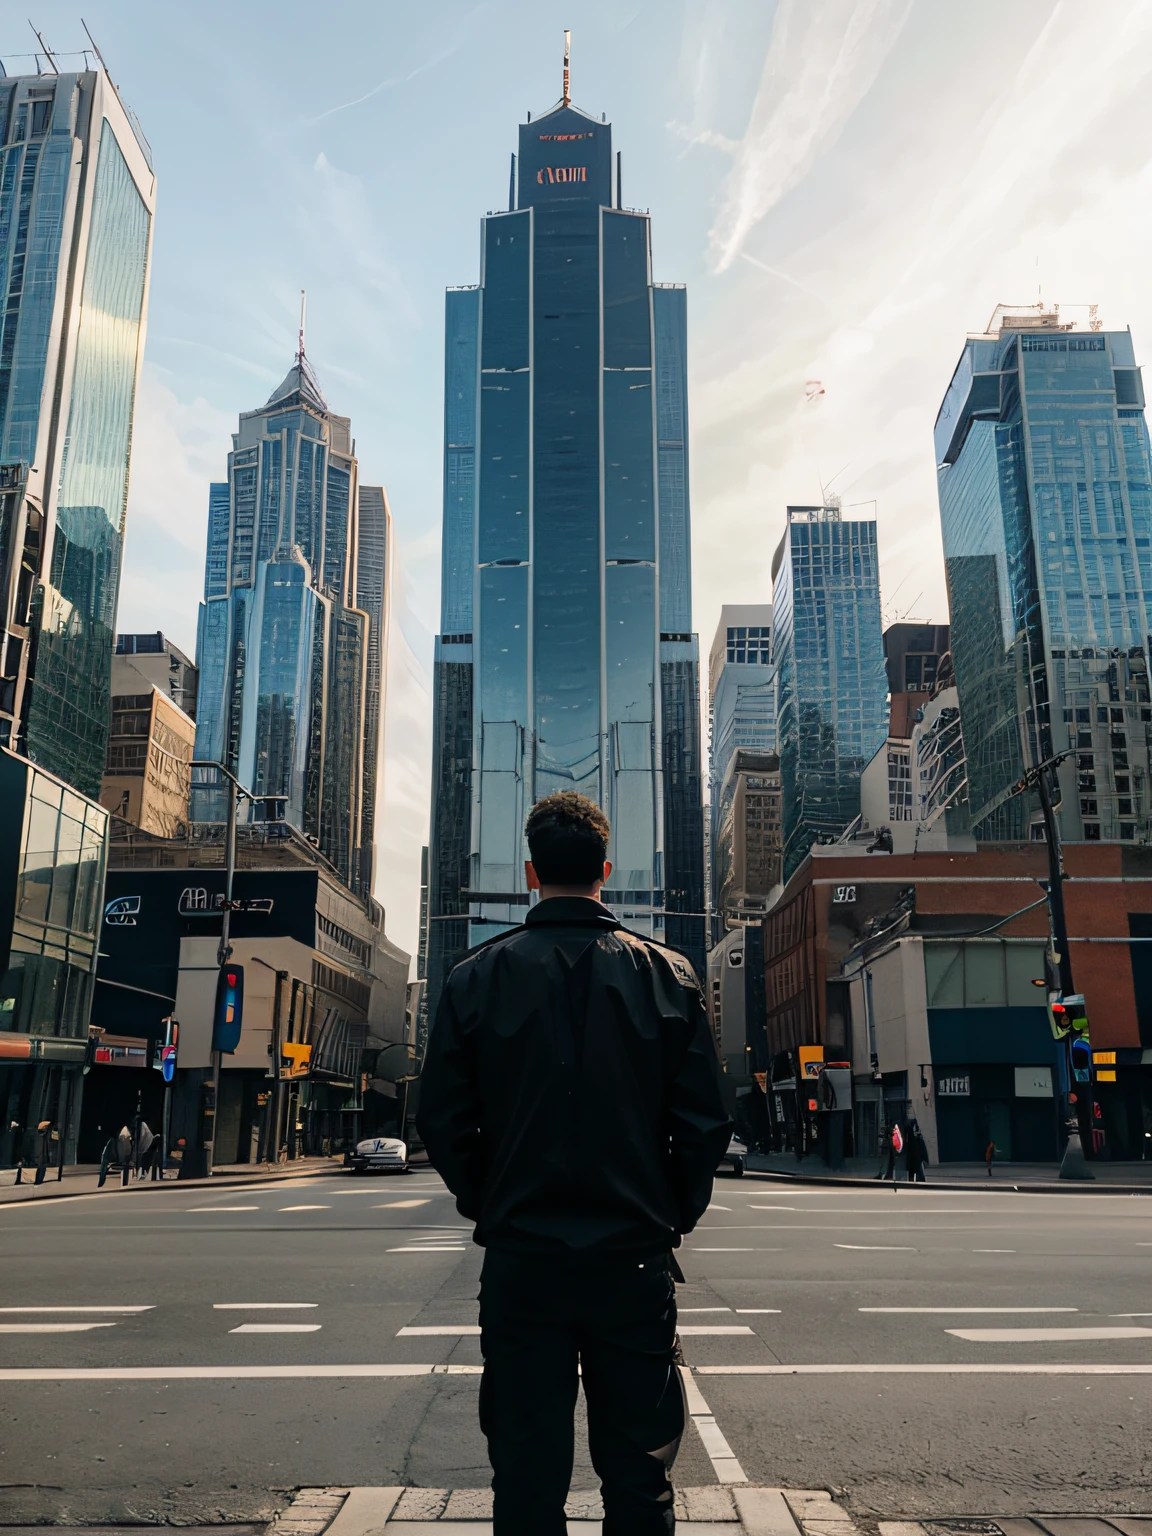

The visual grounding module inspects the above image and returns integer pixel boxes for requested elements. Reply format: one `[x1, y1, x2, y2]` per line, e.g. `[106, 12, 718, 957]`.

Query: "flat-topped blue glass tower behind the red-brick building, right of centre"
[773, 507, 888, 880]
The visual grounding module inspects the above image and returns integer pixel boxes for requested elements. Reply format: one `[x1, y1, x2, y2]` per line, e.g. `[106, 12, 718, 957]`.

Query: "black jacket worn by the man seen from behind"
[416, 897, 731, 1256]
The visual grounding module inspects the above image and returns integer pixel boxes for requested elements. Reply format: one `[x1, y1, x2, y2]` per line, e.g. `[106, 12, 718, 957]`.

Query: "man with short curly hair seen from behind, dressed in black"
[418, 793, 730, 1536]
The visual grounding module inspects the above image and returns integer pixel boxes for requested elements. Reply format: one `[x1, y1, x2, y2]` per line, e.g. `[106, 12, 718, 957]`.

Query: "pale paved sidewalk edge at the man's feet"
[278, 1484, 1152, 1536]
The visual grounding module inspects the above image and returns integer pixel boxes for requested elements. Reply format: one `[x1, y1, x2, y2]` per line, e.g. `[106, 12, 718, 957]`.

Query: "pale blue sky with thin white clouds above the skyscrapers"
[9, 0, 1152, 948]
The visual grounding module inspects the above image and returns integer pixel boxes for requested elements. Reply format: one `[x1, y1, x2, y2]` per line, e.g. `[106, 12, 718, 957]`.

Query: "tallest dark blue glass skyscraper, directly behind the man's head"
[429, 77, 703, 998]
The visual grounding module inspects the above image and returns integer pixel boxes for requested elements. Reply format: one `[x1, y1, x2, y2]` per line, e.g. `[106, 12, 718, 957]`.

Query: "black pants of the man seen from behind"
[479, 1250, 685, 1536]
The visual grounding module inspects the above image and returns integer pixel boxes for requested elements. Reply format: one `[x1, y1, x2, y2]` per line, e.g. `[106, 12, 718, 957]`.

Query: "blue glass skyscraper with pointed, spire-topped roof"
[192, 351, 390, 897]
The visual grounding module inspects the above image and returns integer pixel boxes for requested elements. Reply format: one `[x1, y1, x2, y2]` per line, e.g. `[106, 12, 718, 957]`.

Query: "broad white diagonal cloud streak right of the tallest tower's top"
[708, 0, 911, 272]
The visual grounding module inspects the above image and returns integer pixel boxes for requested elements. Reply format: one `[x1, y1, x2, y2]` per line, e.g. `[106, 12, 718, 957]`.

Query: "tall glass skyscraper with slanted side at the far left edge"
[0, 65, 155, 799]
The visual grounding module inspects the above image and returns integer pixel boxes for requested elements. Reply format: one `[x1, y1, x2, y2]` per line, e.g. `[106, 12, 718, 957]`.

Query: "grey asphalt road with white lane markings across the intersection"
[0, 1172, 1152, 1524]
